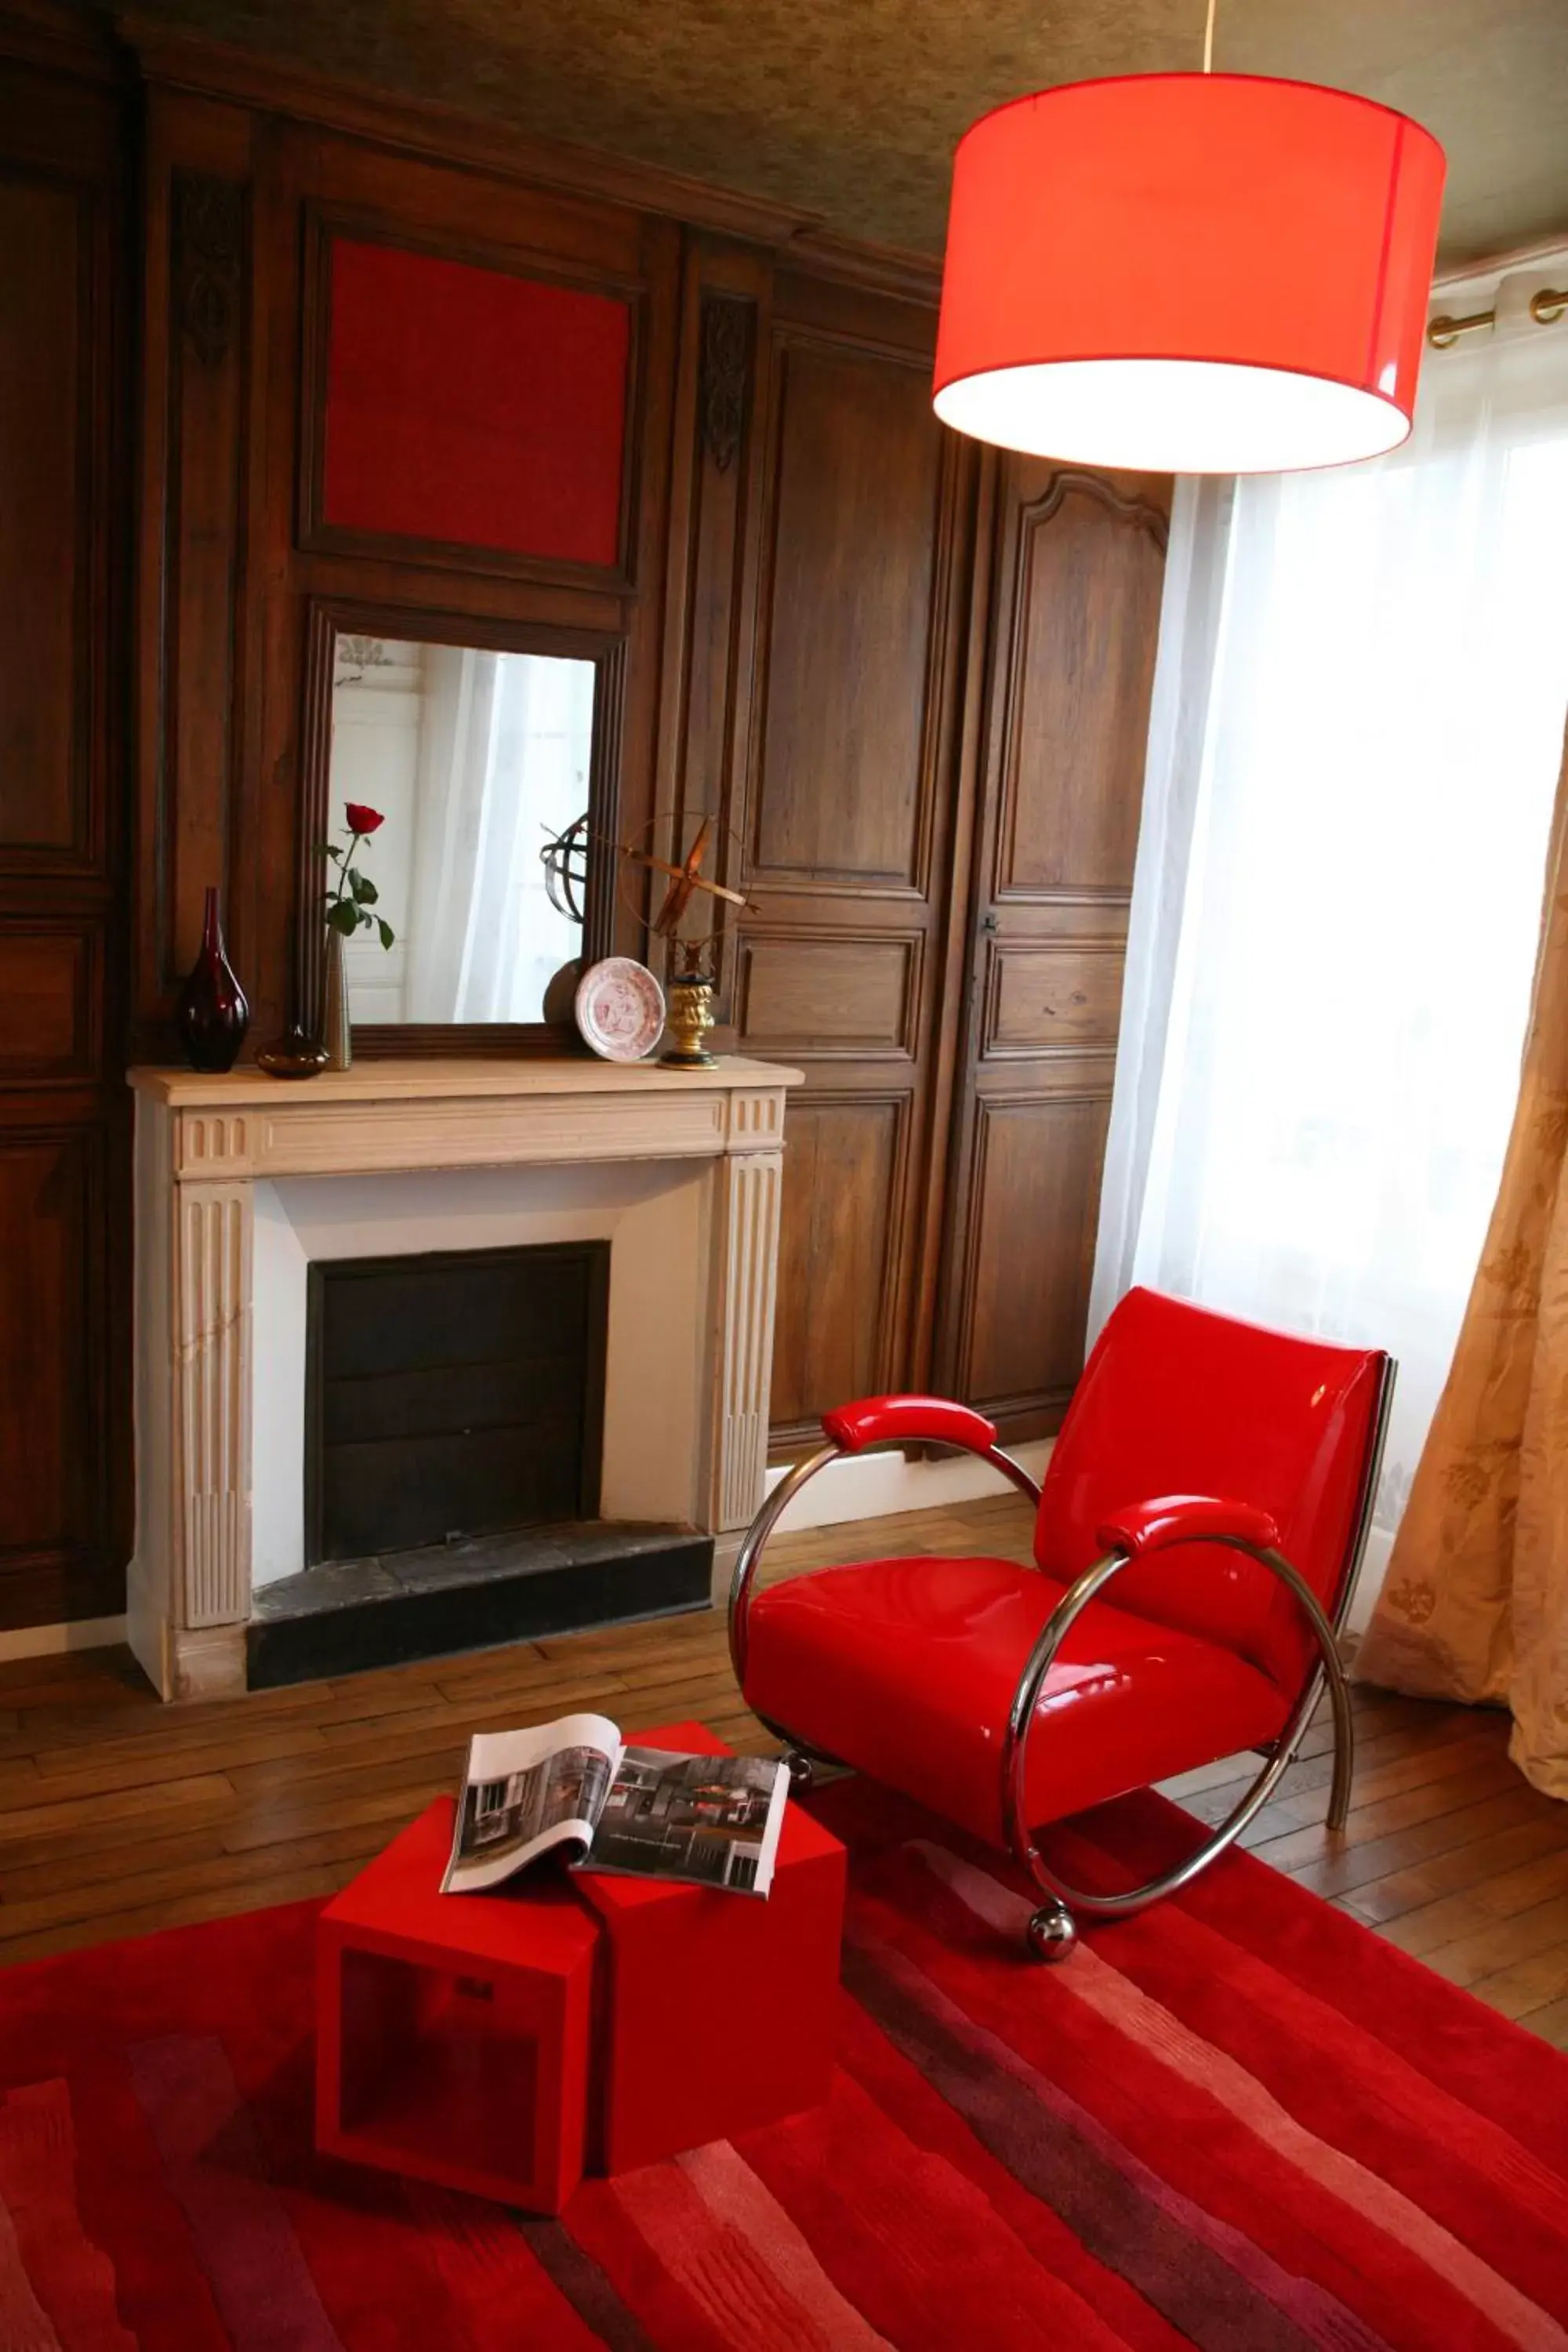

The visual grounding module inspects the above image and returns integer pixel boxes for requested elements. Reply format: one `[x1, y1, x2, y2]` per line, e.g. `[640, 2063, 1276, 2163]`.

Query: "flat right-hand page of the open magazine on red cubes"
[572, 1748, 789, 1896]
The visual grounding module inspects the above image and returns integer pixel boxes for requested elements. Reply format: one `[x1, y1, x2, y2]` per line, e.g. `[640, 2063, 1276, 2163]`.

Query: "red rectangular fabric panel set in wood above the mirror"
[320, 238, 633, 569]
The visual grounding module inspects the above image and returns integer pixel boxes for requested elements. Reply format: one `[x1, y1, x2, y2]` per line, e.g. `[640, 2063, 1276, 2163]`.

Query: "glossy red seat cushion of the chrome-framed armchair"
[746, 1557, 1288, 1844]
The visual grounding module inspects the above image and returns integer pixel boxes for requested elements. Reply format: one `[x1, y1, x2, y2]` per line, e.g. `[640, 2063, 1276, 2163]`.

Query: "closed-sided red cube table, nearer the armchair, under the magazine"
[572, 1724, 844, 2173]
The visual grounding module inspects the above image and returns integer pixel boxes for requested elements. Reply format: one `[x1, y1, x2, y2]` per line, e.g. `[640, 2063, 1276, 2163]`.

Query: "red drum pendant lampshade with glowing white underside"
[935, 73, 1443, 473]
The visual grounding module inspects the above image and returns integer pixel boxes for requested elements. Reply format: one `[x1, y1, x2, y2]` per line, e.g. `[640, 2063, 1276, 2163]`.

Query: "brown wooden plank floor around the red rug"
[0, 1496, 1568, 2049]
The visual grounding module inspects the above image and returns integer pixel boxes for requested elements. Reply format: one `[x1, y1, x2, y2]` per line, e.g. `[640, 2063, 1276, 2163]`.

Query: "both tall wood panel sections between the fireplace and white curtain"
[670, 259, 1168, 1454]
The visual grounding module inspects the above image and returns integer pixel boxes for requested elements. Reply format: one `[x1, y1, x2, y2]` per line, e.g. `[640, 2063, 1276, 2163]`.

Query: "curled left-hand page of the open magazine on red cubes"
[442, 1715, 623, 1893]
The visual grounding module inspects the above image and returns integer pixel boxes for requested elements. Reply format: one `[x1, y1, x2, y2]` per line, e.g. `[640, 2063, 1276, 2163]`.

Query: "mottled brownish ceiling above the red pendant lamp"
[113, 0, 1568, 266]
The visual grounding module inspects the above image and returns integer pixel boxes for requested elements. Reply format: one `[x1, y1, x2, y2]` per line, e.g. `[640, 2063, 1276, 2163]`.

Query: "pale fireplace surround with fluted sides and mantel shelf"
[127, 1058, 799, 1698]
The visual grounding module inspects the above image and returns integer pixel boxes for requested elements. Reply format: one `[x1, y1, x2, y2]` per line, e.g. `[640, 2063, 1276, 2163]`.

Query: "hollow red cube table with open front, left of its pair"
[315, 1797, 597, 2213]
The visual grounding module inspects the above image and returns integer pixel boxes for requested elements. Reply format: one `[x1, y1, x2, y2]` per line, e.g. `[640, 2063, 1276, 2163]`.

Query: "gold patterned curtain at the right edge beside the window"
[1356, 706, 1568, 1797]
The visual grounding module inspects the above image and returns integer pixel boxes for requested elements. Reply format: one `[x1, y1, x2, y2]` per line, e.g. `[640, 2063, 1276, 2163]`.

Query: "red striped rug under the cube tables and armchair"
[0, 1785, 1568, 2352]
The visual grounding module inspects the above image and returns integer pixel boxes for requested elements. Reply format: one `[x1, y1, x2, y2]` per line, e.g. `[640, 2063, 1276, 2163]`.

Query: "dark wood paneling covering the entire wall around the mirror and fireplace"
[0, 0, 1163, 1625]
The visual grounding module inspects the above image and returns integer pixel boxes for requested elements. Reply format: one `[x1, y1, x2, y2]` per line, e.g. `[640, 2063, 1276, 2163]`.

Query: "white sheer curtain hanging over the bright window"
[1091, 270, 1568, 1618]
